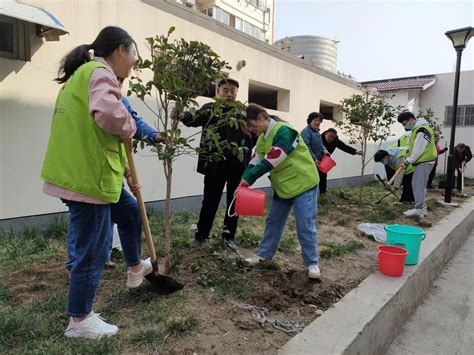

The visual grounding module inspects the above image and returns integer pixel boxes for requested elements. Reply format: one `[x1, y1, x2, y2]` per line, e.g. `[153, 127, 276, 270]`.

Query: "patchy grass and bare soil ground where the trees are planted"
[0, 180, 474, 354]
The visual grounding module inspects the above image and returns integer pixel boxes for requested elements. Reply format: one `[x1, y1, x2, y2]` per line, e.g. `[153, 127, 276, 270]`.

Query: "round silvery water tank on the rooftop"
[274, 36, 338, 73]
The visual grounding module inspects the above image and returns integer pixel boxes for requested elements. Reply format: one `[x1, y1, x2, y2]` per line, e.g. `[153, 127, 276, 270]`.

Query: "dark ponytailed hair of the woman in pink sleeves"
[54, 26, 135, 84]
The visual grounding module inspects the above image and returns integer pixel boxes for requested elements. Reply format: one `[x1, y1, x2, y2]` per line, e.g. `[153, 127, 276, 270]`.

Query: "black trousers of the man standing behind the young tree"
[195, 160, 244, 240]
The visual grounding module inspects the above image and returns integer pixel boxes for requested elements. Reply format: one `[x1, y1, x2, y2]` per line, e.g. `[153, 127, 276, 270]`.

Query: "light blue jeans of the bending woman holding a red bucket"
[258, 187, 318, 266]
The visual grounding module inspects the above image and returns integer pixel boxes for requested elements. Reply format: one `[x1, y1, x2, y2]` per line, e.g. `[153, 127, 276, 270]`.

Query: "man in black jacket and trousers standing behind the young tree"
[176, 79, 255, 251]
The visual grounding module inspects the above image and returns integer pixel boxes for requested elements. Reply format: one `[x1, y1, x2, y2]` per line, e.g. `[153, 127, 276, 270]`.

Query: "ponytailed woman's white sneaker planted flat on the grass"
[64, 312, 118, 339]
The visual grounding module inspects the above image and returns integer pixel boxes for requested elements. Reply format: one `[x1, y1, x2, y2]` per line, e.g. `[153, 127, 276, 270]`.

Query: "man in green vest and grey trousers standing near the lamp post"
[397, 111, 437, 218]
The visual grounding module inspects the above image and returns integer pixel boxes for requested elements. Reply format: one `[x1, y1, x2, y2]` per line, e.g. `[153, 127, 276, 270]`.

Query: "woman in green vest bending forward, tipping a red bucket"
[240, 104, 321, 279]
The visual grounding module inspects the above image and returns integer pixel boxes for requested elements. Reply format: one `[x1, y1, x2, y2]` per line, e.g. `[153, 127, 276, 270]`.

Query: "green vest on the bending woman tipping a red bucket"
[255, 122, 319, 199]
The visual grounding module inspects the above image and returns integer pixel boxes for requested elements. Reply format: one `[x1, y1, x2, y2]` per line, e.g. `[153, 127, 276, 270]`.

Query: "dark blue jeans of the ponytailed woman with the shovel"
[64, 189, 142, 317]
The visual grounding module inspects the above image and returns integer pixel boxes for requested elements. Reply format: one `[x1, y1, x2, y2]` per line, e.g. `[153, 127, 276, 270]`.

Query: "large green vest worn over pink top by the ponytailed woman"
[41, 61, 126, 202]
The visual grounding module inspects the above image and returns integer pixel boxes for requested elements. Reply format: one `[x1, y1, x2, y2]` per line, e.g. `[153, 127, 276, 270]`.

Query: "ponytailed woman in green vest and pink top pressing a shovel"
[41, 26, 152, 339]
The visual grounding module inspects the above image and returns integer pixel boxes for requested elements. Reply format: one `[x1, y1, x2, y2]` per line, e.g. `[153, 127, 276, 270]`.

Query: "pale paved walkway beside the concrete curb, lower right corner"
[386, 232, 474, 355]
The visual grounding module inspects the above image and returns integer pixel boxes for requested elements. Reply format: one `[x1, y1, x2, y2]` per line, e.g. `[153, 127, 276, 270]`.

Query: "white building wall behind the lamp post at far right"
[420, 70, 474, 178]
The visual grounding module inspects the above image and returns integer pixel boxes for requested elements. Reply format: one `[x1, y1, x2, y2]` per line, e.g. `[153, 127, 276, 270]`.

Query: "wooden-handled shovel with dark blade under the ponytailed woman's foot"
[125, 140, 184, 294]
